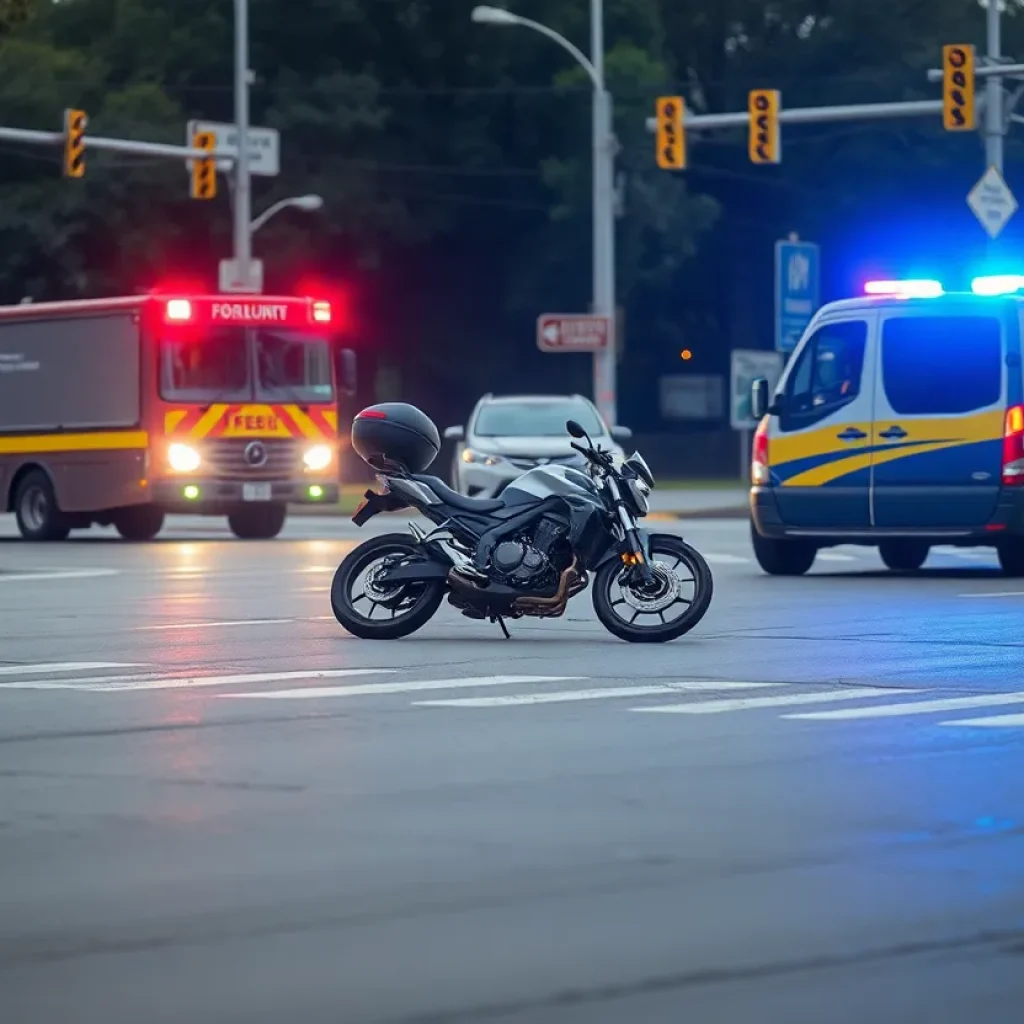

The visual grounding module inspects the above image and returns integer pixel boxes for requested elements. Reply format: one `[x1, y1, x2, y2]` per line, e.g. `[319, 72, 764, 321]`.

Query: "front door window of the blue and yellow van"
[779, 321, 867, 430]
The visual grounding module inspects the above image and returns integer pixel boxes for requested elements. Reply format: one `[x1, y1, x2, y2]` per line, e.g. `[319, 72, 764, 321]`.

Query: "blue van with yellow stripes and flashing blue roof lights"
[750, 278, 1024, 575]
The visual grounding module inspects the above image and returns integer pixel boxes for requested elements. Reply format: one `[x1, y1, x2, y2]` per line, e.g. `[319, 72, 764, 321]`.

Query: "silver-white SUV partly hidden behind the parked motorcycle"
[444, 394, 633, 498]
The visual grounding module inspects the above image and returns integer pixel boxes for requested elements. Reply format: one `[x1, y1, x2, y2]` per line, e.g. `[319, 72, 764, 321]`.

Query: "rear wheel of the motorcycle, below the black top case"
[331, 534, 445, 640]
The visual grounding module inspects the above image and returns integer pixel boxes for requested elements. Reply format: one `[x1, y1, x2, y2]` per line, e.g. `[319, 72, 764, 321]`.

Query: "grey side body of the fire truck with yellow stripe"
[0, 307, 152, 513]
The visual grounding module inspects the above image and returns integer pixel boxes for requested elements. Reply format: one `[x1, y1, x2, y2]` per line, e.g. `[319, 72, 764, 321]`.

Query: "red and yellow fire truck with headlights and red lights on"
[0, 295, 355, 541]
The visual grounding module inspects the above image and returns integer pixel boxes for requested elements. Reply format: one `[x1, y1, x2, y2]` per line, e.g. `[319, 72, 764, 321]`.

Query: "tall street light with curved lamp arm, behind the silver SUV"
[471, 0, 617, 427]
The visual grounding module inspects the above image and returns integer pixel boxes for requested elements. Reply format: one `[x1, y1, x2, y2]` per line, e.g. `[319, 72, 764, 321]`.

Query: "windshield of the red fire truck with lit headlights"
[160, 327, 334, 402]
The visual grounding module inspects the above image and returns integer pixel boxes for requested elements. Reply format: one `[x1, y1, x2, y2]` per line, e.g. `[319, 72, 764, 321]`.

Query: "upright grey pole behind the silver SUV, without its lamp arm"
[590, 0, 621, 428]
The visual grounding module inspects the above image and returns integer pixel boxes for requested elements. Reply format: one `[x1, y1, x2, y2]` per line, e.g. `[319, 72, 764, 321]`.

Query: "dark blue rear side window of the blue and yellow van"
[882, 316, 1002, 416]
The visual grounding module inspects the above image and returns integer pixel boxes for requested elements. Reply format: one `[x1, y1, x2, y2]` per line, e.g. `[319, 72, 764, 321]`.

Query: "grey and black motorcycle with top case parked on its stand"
[331, 403, 714, 643]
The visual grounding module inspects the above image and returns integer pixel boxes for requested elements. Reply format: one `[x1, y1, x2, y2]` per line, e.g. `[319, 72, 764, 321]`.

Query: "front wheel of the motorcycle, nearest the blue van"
[592, 534, 715, 643]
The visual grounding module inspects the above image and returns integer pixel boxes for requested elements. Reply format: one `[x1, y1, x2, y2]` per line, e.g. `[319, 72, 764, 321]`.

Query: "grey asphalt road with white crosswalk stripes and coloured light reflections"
[0, 519, 1024, 1024]
